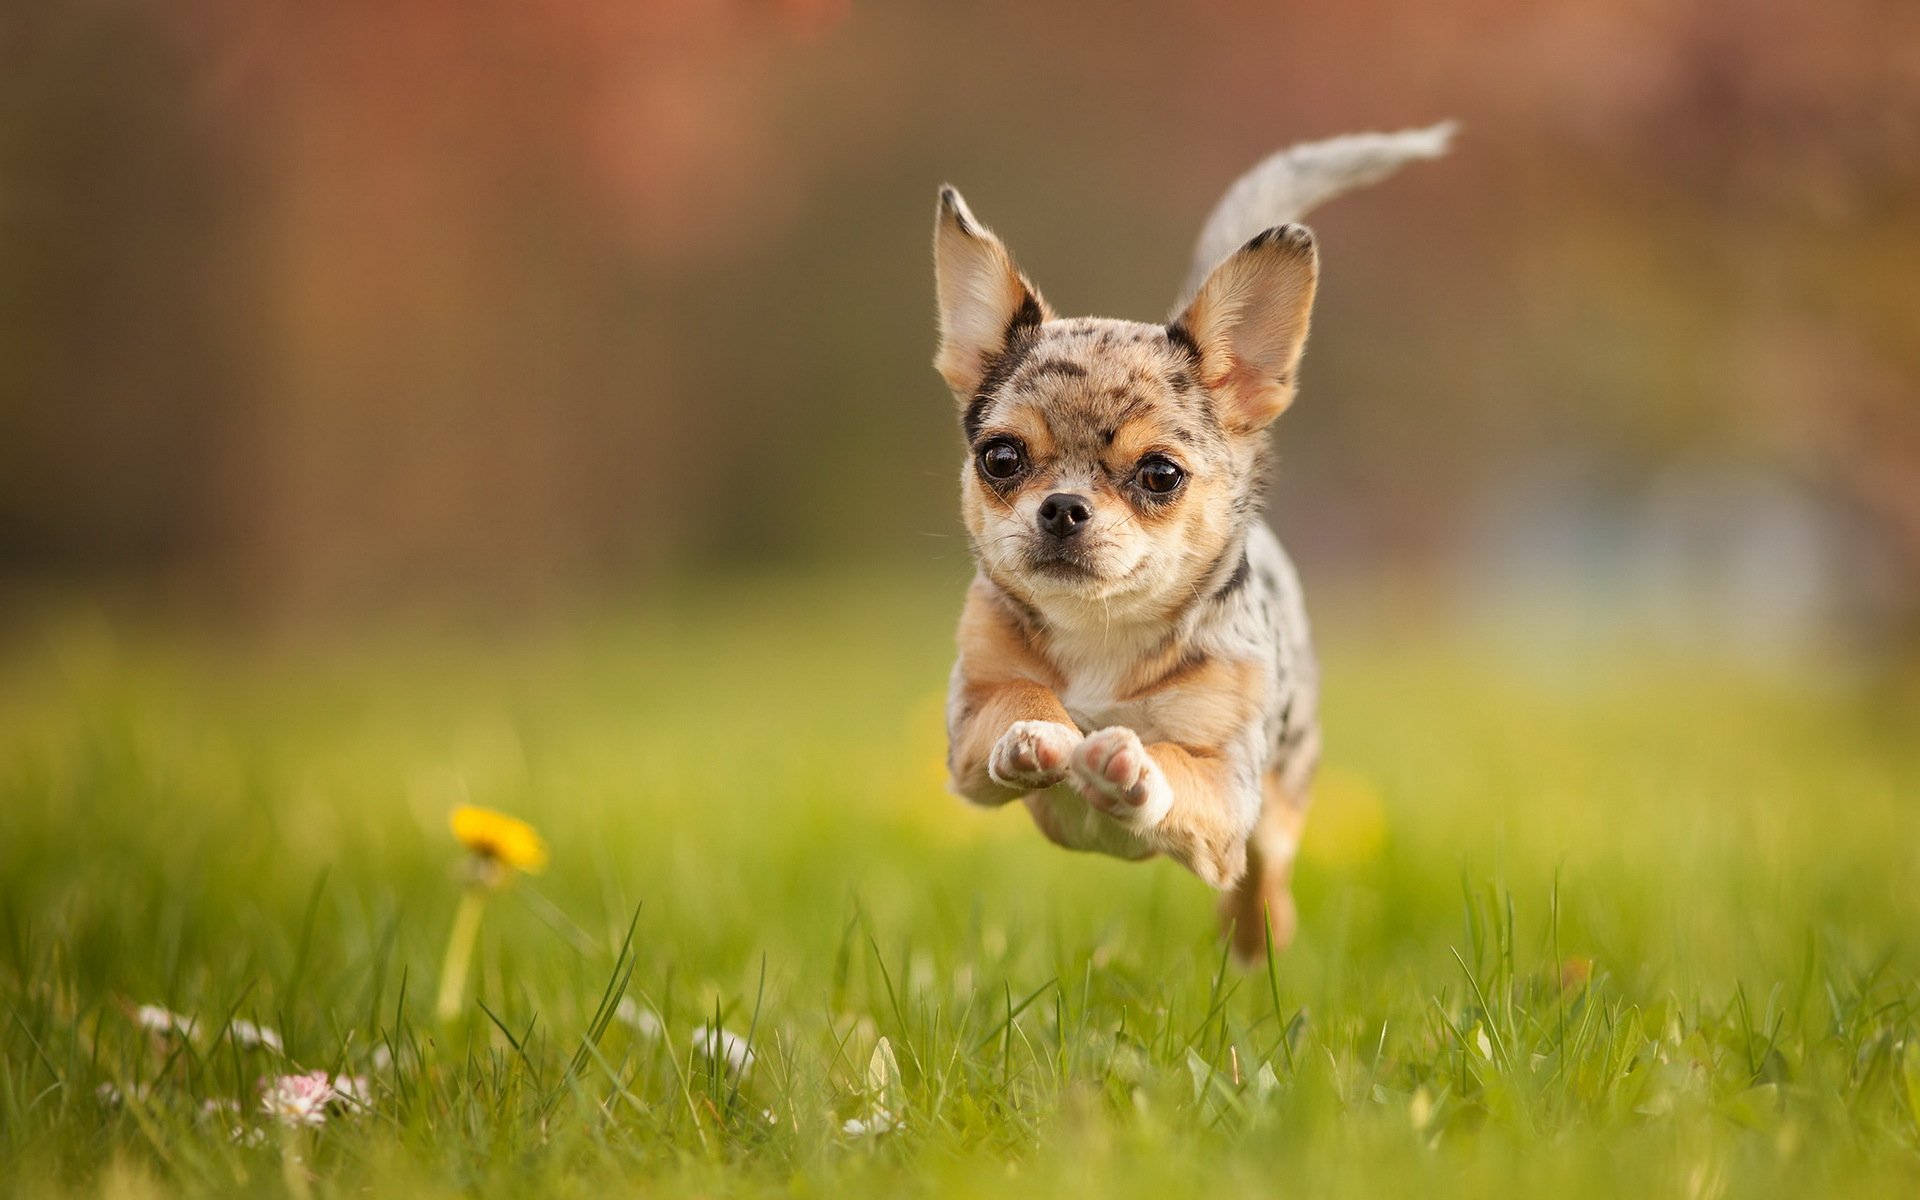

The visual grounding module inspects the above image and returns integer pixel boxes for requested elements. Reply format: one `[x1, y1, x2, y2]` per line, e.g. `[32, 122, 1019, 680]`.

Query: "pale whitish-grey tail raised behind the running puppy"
[1173, 121, 1457, 313]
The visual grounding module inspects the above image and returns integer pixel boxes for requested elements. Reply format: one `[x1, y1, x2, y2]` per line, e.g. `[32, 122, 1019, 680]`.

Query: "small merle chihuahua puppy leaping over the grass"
[933, 125, 1452, 962]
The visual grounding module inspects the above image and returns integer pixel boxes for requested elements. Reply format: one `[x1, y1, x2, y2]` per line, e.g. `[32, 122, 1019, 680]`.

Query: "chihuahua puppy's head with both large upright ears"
[933, 188, 1319, 618]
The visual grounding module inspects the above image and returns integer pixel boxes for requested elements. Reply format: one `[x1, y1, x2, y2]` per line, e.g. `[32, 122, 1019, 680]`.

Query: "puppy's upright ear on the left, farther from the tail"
[933, 186, 1052, 395]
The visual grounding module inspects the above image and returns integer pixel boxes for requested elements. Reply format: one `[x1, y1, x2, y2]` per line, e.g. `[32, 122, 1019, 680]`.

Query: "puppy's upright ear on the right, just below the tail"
[1173, 225, 1319, 434]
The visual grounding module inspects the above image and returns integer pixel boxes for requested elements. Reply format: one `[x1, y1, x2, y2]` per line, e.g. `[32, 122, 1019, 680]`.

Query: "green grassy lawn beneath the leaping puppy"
[0, 582, 1920, 1198]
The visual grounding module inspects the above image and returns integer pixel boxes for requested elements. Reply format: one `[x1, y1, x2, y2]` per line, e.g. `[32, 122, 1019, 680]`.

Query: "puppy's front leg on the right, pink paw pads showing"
[1069, 726, 1260, 889]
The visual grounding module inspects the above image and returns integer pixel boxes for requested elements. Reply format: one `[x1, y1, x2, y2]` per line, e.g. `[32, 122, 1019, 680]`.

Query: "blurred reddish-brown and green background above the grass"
[0, 0, 1920, 666]
